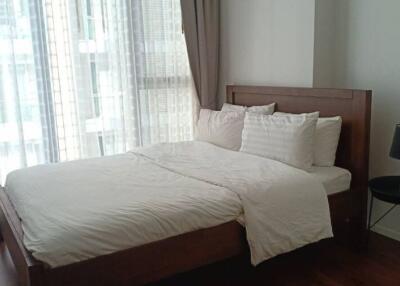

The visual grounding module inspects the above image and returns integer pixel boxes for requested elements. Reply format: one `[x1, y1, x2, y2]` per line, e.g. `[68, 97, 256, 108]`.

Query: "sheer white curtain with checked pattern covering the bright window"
[0, 0, 194, 182]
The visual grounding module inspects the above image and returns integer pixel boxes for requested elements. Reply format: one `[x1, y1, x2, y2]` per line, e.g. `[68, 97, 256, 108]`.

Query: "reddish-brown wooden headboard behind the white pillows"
[226, 85, 372, 193]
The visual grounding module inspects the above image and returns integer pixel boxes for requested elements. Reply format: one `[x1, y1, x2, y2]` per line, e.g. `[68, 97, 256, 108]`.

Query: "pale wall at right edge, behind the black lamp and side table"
[328, 0, 400, 240]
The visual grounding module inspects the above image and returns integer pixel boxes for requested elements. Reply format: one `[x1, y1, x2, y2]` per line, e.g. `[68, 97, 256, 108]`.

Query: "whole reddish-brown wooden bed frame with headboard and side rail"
[0, 86, 371, 286]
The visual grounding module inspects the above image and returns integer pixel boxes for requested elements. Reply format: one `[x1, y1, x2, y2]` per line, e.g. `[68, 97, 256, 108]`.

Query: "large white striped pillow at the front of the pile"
[240, 112, 317, 170]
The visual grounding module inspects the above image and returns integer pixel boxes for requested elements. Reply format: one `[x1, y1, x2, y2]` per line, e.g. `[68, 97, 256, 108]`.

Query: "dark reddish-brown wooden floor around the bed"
[0, 234, 400, 286]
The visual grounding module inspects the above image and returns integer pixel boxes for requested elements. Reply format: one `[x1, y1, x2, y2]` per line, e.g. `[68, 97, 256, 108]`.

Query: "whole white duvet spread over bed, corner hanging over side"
[6, 142, 332, 267]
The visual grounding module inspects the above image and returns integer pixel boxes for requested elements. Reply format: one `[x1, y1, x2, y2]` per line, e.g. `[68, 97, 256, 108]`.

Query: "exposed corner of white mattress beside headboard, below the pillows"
[310, 166, 351, 195]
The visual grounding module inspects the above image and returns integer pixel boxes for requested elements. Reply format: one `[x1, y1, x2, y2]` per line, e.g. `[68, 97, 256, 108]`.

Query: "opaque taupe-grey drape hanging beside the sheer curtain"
[181, 0, 220, 109]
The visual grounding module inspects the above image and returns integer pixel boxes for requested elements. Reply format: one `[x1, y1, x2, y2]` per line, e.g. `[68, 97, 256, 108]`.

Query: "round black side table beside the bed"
[368, 176, 400, 237]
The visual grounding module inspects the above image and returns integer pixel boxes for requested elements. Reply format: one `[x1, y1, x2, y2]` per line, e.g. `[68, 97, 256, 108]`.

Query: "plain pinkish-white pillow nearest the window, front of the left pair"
[194, 109, 245, 151]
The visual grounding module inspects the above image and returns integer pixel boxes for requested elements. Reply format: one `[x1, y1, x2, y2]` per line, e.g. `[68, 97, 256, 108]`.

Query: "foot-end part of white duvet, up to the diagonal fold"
[5, 153, 242, 267]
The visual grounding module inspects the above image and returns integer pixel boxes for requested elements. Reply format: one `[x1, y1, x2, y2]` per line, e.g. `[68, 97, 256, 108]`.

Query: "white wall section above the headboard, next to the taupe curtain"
[219, 0, 315, 105]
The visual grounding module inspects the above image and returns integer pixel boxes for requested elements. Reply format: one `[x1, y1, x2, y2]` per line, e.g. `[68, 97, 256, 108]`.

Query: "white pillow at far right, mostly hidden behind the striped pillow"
[274, 112, 342, 167]
